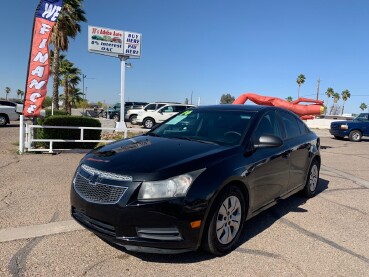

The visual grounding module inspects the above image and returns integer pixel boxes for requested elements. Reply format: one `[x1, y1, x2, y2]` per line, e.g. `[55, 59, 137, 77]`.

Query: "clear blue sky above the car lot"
[0, 0, 369, 113]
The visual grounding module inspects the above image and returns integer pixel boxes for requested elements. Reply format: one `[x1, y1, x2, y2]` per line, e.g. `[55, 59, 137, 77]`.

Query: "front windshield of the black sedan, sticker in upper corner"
[147, 109, 255, 145]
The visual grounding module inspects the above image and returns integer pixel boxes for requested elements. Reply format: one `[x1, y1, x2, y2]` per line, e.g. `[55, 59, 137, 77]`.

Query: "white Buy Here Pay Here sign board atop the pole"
[88, 26, 142, 58]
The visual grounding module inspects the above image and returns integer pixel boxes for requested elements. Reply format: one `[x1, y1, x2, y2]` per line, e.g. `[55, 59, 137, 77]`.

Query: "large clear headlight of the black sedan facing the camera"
[138, 168, 205, 200]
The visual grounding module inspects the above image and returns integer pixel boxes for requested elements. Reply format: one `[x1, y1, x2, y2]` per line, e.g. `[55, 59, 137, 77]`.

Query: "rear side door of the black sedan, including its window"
[280, 111, 311, 190]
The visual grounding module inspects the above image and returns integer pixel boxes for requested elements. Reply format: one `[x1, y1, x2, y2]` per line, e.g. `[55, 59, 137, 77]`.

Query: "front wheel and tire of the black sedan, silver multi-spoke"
[202, 186, 246, 256]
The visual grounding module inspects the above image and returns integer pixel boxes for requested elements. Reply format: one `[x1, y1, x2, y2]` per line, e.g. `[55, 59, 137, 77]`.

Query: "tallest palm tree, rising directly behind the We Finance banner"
[50, 0, 87, 109]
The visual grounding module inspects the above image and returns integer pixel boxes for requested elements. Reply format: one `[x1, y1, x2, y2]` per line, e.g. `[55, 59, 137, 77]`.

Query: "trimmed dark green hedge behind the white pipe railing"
[38, 115, 101, 149]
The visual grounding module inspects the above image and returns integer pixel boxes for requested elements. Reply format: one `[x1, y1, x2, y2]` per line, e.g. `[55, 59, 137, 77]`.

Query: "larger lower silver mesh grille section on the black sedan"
[74, 173, 127, 204]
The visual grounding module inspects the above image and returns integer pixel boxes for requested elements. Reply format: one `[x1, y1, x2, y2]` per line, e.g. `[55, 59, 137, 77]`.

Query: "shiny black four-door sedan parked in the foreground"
[71, 105, 321, 255]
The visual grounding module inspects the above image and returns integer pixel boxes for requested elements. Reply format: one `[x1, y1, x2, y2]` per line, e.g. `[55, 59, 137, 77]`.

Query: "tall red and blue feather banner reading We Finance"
[23, 0, 63, 117]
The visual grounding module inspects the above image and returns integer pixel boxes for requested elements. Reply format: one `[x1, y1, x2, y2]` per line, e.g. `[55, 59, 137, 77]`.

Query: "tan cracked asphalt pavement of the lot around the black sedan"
[0, 122, 369, 277]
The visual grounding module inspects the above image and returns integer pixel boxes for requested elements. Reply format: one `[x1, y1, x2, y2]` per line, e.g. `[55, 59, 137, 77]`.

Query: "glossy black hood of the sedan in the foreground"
[81, 136, 236, 181]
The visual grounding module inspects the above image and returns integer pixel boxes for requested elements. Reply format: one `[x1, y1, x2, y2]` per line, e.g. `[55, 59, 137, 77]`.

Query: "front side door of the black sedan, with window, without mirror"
[246, 111, 289, 211]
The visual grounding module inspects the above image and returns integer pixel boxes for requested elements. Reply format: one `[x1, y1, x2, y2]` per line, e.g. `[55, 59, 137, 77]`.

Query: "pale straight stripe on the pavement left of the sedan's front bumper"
[0, 220, 85, 242]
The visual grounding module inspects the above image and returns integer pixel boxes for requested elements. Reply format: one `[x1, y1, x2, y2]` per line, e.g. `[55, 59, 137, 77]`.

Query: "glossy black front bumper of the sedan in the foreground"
[71, 176, 205, 253]
